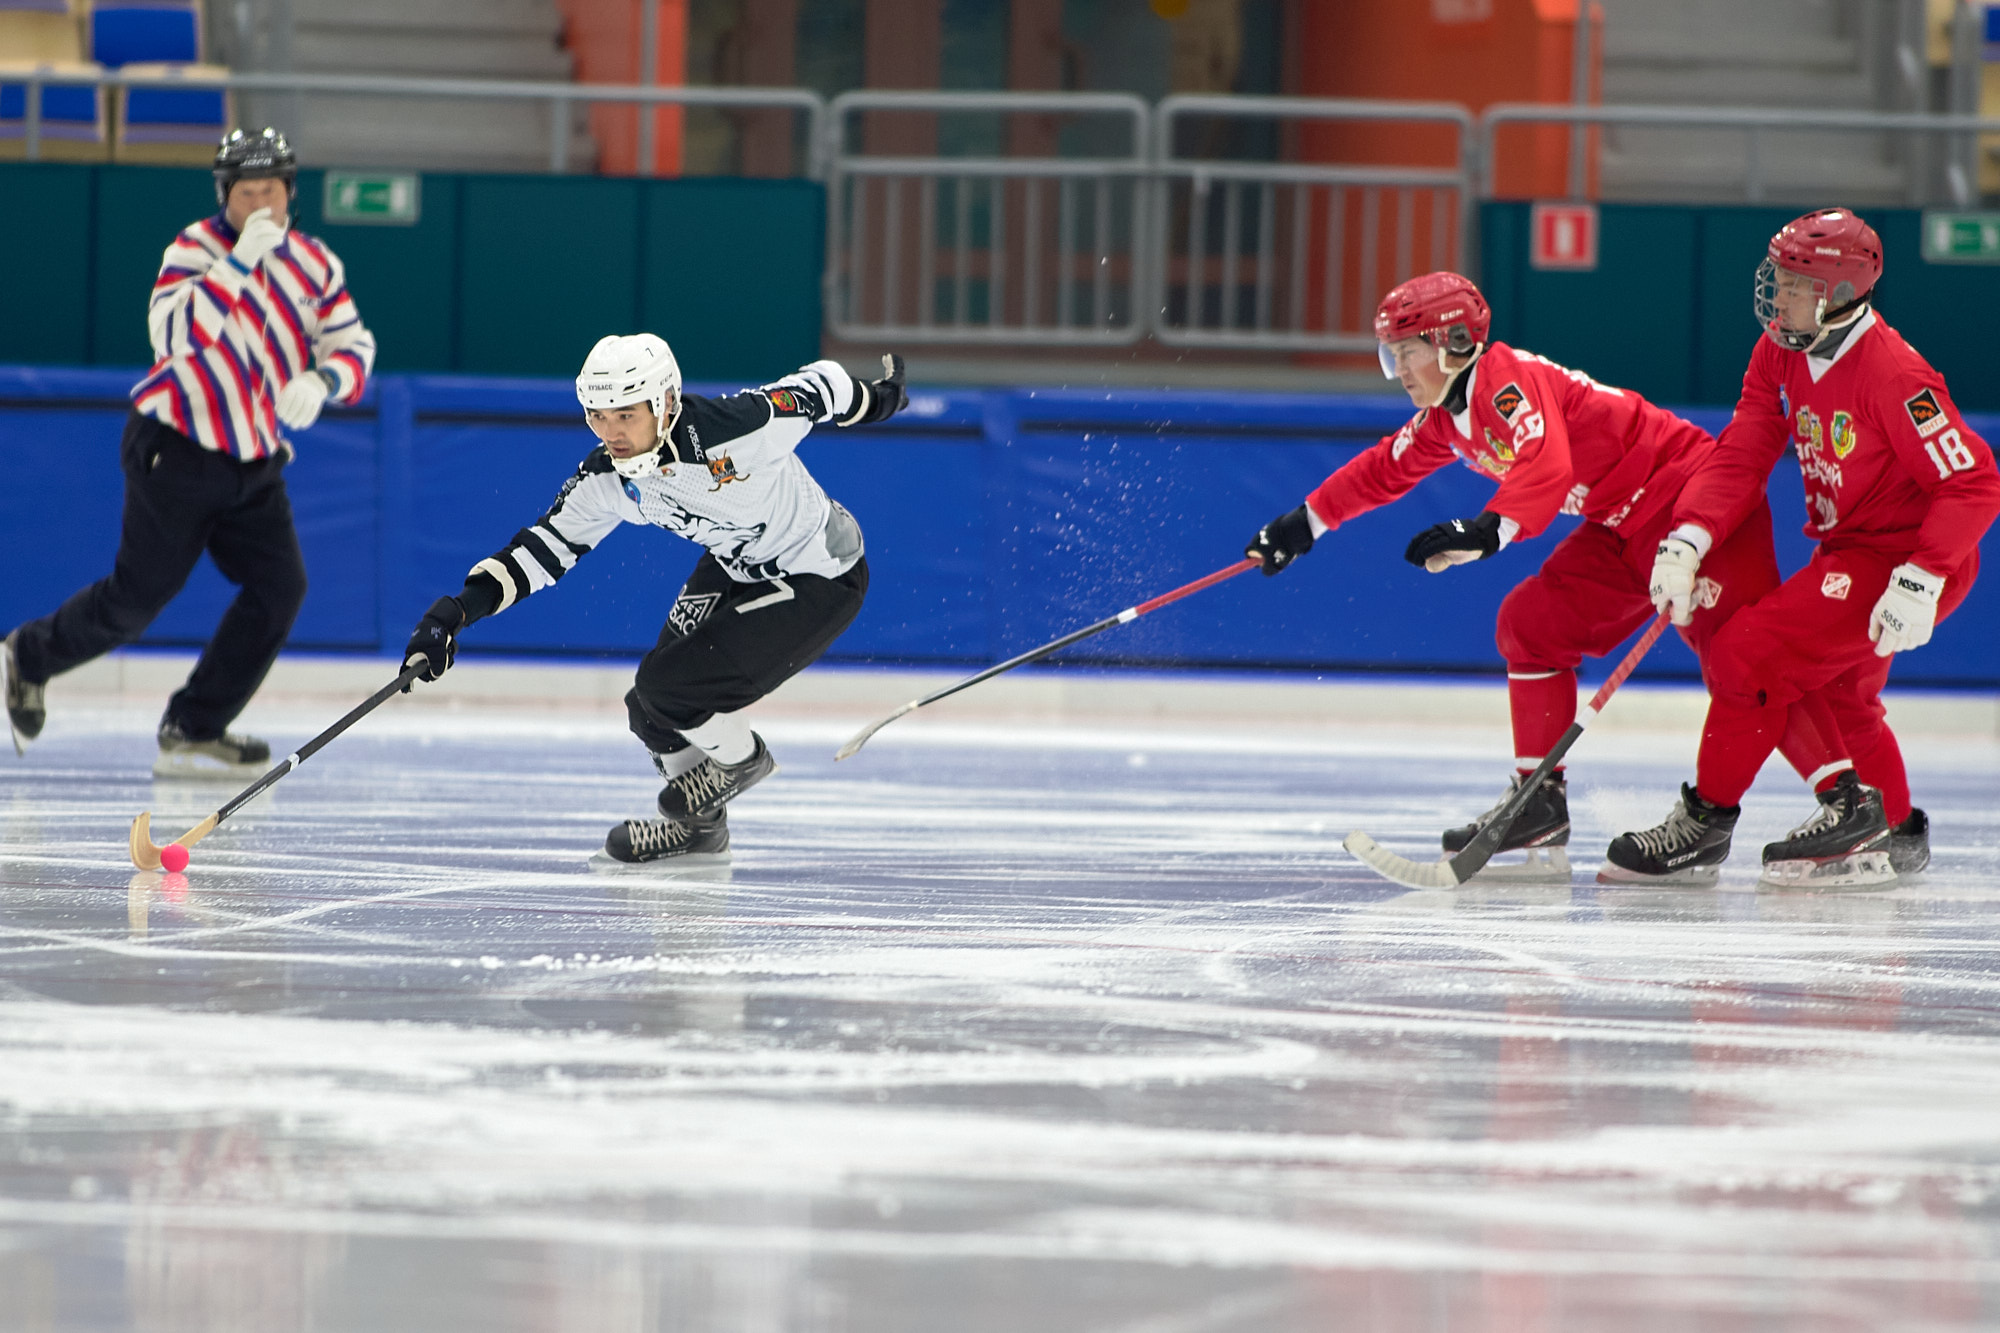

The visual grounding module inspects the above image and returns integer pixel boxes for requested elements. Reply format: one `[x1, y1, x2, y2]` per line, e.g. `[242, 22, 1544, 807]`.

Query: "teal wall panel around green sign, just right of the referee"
[298, 172, 458, 374]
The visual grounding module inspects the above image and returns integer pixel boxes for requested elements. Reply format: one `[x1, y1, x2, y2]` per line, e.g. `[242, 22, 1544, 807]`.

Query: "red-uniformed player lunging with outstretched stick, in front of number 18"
[1244, 272, 1830, 879]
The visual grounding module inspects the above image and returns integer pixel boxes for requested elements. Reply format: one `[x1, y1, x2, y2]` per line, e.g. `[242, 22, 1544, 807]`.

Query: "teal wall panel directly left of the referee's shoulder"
[88, 166, 216, 366]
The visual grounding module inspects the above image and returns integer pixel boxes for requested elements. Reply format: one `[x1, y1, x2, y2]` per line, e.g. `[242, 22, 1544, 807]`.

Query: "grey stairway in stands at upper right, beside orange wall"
[1600, 0, 1910, 206]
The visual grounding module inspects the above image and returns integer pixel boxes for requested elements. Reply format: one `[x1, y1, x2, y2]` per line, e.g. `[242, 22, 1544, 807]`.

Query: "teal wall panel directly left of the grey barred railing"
[638, 178, 826, 382]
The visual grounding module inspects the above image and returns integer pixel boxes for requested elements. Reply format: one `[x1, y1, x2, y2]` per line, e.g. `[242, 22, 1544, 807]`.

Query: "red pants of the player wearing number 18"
[1694, 546, 1978, 825]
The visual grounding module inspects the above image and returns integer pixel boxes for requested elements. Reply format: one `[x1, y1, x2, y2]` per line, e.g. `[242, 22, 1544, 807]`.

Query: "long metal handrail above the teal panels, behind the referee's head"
[4, 68, 826, 180]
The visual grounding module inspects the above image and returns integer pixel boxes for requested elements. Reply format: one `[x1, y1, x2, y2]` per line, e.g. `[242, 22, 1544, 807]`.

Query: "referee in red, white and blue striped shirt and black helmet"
[0, 130, 374, 777]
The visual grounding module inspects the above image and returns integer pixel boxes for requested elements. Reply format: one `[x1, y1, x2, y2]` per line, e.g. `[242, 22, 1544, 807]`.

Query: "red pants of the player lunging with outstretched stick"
[1494, 504, 1844, 780]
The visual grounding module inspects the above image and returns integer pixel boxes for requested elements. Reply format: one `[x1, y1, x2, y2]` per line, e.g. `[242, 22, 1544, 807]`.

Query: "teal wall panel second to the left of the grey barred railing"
[458, 176, 644, 376]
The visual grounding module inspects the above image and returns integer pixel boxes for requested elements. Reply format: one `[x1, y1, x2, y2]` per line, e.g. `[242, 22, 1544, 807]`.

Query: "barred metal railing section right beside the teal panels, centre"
[826, 92, 1152, 344]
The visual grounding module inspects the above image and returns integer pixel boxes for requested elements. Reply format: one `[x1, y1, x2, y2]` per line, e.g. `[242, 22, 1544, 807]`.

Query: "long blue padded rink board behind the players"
[0, 368, 2000, 687]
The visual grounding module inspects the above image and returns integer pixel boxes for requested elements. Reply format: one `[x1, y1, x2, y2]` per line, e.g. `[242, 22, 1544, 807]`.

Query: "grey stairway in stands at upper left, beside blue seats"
[238, 0, 596, 172]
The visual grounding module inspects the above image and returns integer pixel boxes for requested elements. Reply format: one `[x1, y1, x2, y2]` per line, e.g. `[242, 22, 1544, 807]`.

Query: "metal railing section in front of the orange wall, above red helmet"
[1148, 96, 1474, 350]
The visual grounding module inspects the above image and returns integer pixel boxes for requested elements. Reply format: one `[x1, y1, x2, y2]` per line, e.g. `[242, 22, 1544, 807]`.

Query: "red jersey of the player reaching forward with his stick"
[1306, 342, 1726, 536]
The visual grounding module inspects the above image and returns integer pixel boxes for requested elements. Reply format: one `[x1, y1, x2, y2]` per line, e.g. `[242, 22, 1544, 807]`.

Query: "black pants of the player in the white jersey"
[626, 554, 868, 755]
